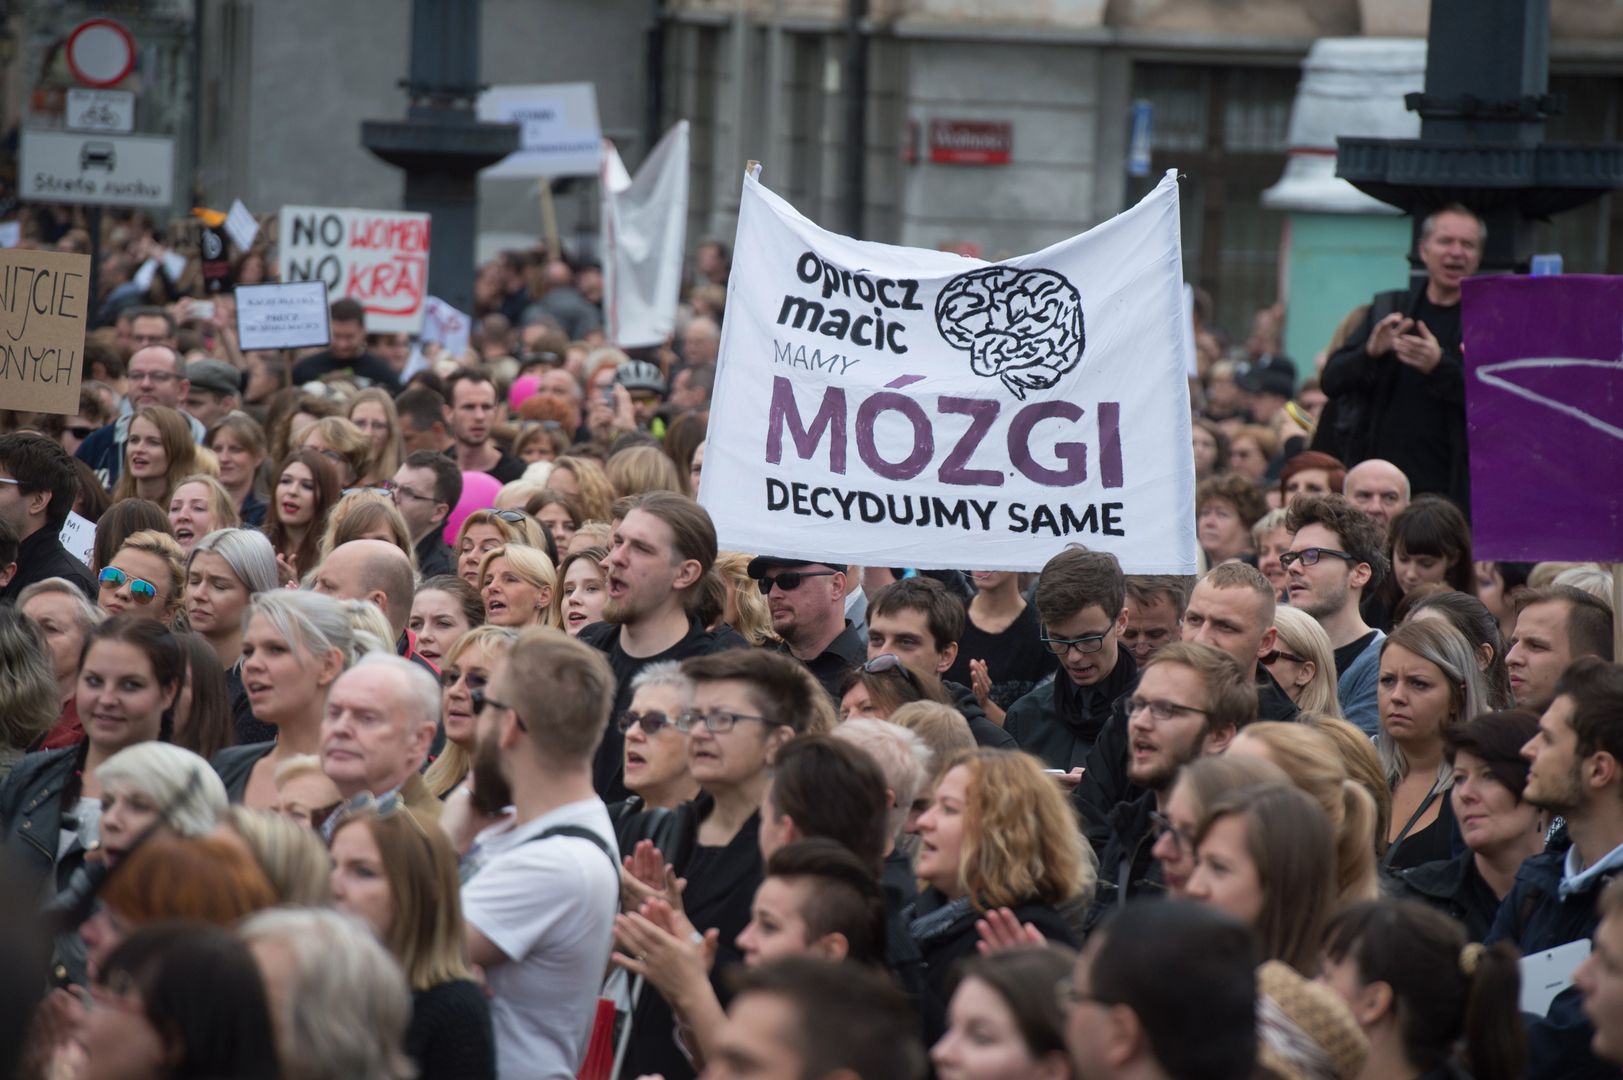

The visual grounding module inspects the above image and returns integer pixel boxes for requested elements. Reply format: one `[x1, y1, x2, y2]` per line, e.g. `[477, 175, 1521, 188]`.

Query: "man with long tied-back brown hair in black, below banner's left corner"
[579, 492, 745, 802]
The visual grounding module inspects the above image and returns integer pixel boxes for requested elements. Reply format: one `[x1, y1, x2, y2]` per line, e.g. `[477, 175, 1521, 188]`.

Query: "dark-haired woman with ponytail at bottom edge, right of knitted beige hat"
[1321, 900, 1527, 1080]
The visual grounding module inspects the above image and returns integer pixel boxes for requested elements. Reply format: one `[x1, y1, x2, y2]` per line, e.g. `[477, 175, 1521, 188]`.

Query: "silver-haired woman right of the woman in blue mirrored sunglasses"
[185, 529, 281, 744]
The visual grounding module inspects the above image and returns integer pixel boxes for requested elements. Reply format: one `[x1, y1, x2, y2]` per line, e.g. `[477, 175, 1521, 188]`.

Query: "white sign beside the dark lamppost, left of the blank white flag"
[479, 83, 604, 179]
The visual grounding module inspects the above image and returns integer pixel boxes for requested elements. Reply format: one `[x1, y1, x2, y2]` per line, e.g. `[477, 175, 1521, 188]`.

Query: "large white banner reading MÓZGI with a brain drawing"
[700, 172, 1196, 573]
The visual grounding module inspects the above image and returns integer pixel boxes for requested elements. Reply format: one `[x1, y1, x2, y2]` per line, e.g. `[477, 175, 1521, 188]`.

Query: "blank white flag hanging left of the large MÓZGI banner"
[601, 120, 688, 348]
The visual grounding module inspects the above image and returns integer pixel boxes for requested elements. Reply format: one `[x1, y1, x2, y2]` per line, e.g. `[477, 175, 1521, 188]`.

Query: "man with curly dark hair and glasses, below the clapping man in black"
[1279, 495, 1388, 736]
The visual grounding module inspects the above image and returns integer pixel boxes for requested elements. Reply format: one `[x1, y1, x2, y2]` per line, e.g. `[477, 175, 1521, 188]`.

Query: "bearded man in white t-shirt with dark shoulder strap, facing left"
[463, 629, 620, 1077]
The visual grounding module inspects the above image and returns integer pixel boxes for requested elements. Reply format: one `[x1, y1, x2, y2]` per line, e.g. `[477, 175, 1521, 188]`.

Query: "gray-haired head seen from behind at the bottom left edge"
[240, 908, 415, 1080]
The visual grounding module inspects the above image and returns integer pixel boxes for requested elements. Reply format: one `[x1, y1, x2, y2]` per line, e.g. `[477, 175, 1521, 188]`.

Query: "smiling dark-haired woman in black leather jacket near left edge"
[0, 614, 185, 893]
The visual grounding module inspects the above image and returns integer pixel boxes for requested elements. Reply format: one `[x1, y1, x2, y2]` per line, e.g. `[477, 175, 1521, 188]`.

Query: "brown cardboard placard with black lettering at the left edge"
[0, 247, 91, 416]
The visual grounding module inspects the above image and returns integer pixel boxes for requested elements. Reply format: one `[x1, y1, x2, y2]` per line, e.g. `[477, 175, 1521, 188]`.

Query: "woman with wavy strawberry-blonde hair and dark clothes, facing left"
[902, 750, 1096, 1044]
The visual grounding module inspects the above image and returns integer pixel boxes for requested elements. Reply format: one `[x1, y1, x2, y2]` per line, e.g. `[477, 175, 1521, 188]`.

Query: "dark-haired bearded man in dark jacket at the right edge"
[1487, 656, 1623, 1077]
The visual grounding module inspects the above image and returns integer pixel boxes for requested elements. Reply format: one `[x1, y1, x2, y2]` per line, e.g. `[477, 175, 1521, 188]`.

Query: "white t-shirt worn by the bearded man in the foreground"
[463, 797, 620, 1080]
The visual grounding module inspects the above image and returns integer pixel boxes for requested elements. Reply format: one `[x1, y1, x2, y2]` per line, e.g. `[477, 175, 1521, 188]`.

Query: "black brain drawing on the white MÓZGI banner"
[935, 266, 1086, 401]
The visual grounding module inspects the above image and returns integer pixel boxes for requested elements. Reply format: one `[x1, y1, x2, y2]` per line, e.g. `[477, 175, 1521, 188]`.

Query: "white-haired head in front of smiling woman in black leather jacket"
[96, 742, 229, 866]
